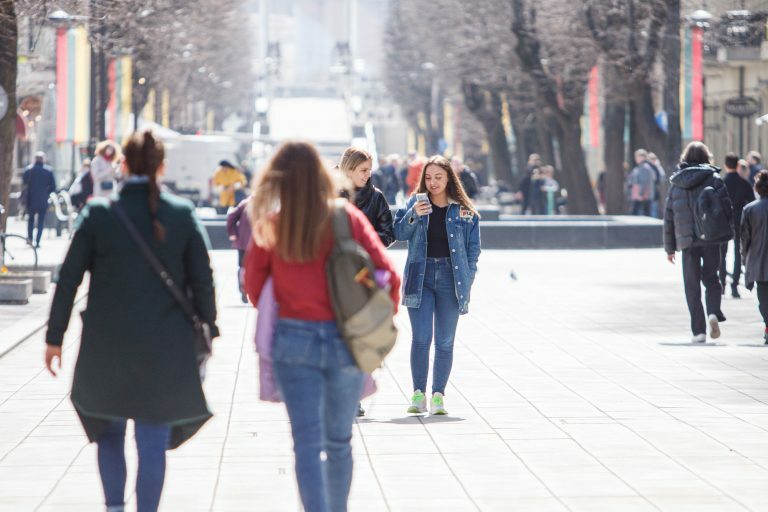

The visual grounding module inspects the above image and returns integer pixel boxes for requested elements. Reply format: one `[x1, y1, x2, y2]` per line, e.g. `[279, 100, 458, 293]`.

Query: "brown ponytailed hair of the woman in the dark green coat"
[123, 130, 165, 241]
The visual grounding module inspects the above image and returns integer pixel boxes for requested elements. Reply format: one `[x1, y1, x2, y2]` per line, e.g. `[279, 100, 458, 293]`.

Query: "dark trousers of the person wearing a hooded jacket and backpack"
[683, 245, 725, 336]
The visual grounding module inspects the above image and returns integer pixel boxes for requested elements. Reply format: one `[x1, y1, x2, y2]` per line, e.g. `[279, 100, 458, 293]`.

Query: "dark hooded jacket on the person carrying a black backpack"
[664, 162, 733, 254]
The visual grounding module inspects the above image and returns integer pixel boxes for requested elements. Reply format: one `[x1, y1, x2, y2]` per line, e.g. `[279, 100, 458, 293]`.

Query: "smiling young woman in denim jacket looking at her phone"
[395, 156, 480, 414]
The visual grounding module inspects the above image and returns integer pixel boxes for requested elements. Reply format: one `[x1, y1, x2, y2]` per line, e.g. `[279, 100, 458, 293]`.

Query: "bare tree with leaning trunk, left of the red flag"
[511, 0, 597, 215]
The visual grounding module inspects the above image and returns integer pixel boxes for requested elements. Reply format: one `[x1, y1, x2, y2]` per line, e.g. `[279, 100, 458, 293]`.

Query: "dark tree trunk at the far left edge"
[0, 0, 18, 231]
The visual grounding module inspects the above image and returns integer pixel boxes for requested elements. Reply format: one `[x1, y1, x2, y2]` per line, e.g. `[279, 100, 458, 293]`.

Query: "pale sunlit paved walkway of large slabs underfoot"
[0, 243, 768, 512]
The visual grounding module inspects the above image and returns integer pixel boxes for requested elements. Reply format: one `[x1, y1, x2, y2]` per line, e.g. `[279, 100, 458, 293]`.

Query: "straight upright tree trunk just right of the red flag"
[603, 65, 627, 215]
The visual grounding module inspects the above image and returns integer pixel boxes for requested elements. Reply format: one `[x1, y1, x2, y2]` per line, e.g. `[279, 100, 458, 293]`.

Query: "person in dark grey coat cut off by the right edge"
[741, 170, 768, 345]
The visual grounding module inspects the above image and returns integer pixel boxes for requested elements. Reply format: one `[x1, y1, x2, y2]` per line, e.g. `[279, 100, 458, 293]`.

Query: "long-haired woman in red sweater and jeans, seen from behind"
[245, 142, 400, 512]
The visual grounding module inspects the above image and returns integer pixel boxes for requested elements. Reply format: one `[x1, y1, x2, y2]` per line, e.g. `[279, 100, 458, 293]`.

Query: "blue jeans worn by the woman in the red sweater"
[272, 318, 363, 512]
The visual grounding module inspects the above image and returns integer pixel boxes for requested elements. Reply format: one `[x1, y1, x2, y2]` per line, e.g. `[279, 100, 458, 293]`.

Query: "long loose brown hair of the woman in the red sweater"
[251, 142, 337, 263]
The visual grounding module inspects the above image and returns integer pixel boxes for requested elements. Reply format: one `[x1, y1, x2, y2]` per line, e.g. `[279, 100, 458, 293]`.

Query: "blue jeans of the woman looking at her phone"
[408, 258, 459, 394]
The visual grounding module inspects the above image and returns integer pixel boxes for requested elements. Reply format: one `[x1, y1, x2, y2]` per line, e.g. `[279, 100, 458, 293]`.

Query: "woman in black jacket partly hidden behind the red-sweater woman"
[339, 147, 395, 417]
